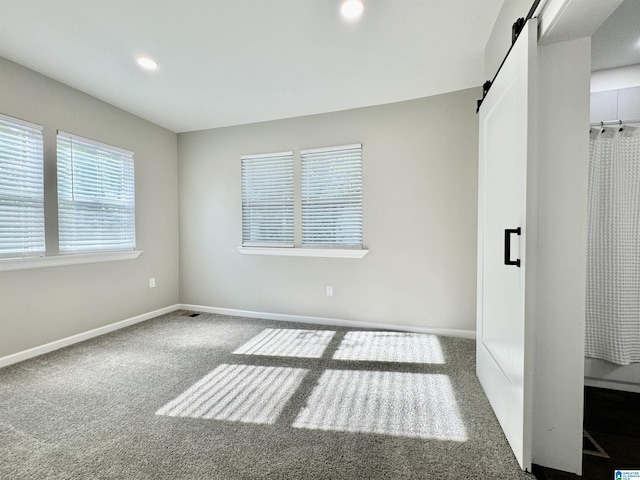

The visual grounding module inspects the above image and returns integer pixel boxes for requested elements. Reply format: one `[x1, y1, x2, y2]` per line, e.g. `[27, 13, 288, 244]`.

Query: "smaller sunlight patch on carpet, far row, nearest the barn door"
[333, 332, 444, 364]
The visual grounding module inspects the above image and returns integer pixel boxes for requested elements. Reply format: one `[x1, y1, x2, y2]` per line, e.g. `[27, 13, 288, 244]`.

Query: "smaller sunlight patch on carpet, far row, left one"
[233, 328, 336, 358]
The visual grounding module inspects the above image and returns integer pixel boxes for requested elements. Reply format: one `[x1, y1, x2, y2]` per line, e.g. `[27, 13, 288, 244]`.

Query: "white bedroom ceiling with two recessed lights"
[0, 0, 503, 132]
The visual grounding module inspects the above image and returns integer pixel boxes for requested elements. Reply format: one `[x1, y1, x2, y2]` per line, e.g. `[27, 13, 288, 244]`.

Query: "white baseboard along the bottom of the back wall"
[180, 304, 476, 339]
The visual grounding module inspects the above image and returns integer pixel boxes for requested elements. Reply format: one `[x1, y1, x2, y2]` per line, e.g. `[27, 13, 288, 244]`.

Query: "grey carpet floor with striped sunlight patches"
[0, 312, 533, 480]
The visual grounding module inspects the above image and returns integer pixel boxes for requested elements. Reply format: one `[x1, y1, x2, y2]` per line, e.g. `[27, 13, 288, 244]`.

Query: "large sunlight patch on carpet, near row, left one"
[156, 364, 307, 424]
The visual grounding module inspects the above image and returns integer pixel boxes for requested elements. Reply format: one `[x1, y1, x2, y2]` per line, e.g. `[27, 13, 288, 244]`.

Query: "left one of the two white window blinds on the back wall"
[242, 152, 293, 247]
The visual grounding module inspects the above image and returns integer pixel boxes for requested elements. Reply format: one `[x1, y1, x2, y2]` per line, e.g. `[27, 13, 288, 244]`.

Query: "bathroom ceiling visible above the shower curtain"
[591, 0, 640, 71]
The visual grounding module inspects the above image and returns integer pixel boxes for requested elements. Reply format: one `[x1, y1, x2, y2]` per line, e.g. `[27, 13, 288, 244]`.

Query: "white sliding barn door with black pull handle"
[476, 19, 537, 471]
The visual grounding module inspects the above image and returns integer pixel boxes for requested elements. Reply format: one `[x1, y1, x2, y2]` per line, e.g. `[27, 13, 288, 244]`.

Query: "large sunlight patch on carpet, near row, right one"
[293, 370, 467, 442]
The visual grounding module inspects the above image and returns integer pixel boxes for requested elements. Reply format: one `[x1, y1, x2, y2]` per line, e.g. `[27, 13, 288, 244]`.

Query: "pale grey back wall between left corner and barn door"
[178, 89, 479, 331]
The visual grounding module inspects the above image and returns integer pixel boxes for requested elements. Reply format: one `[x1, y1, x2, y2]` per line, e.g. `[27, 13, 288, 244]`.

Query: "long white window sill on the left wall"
[0, 250, 142, 272]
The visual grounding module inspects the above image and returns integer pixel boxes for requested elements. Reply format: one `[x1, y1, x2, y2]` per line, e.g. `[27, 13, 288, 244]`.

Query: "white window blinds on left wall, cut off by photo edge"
[0, 115, 45, 257]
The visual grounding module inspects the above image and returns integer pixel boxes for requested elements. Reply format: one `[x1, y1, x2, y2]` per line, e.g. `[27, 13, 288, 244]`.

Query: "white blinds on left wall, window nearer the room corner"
[58, 132, 136, 253]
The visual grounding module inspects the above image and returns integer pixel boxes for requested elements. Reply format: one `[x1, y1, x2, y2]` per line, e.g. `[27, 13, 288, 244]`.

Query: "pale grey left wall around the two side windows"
[0, 57, 178, 358]
